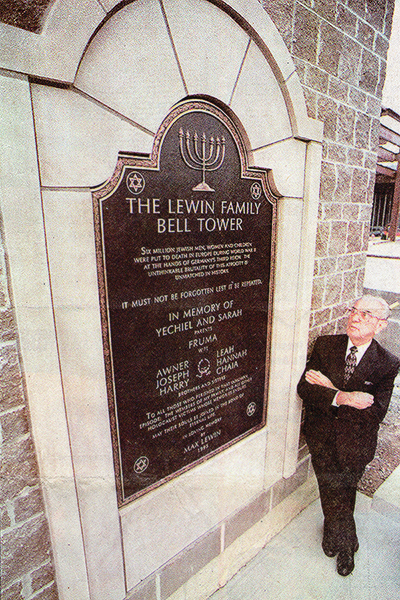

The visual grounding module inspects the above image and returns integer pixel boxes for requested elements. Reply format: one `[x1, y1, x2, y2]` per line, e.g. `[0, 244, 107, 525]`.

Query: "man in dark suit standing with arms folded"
[297, 296, 400, 576]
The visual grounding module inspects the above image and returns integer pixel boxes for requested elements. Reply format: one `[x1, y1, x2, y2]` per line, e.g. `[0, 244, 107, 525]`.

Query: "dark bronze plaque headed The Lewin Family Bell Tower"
[93, 100, 275, 504]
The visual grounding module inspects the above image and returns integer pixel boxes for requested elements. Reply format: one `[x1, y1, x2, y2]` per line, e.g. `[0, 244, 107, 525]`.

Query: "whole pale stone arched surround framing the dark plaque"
[0, 0, 322, 600]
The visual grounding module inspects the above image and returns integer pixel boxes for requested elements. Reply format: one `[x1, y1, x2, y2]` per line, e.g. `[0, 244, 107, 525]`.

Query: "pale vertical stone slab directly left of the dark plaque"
[42, 190, 125, 600]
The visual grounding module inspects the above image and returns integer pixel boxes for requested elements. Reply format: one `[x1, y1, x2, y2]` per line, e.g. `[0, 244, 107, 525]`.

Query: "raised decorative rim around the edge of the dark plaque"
[91, 97, 278, 507]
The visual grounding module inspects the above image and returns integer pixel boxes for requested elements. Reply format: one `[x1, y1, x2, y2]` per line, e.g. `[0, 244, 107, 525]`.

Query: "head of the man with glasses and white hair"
[346, 298, 387, 346]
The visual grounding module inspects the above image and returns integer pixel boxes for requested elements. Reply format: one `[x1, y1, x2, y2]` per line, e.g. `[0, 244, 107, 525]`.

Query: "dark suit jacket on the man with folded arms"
[297, 335, 400, 471]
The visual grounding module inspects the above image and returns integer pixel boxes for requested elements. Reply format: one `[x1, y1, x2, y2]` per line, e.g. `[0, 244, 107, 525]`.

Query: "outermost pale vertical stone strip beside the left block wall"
[0, 77, 89, 600]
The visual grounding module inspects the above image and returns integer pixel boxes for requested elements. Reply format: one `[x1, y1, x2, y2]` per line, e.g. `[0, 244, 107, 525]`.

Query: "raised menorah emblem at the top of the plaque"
[179, 127, 225, 192]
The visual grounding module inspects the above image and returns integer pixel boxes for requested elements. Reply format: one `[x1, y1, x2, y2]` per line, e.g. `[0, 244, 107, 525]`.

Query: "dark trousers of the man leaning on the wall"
[311, 445, 363, 551]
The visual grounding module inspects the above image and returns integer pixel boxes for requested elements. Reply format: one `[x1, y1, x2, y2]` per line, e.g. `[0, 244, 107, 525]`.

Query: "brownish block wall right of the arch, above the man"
[262, 0, 394, 339]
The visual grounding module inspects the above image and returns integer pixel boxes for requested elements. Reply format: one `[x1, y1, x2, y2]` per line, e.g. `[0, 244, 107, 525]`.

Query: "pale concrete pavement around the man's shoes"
[209, 494, 400, 600]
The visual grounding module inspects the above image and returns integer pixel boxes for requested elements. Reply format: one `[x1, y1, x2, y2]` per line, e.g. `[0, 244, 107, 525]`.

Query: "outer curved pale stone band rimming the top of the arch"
[0, 0, 321, 141]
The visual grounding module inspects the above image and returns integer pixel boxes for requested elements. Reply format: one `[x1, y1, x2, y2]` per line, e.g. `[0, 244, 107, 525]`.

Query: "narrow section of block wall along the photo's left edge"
[0, 214, 58, 600]
